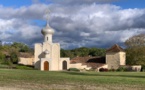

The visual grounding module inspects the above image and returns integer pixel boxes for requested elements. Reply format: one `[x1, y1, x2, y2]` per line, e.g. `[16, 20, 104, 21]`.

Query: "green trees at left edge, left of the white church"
[0, 42, 33, 65]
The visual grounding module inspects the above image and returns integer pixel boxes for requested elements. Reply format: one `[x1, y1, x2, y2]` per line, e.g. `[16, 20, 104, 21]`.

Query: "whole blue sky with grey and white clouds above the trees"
[0, 0, 145, 49]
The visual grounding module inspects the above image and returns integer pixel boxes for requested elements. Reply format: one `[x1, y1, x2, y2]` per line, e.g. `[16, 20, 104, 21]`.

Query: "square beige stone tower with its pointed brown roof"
[106, 44, 126, 69]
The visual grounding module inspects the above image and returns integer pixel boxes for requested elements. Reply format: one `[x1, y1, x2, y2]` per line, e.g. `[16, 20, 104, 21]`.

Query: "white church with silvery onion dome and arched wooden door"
[34, 24, 70, 71]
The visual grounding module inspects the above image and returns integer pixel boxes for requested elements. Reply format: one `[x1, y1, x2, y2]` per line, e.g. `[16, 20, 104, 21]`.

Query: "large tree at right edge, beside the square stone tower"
[125, 34, 145, 66]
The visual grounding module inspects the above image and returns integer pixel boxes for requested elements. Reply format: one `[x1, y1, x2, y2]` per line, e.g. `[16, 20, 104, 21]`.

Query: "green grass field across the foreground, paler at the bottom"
[0, 69, 145, 90]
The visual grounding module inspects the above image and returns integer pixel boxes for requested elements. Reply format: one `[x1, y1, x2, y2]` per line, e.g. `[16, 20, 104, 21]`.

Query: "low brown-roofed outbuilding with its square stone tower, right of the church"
[70, 44, 126, 71]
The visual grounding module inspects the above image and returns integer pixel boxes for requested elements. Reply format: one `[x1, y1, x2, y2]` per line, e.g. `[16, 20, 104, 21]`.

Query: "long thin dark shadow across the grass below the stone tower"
[62, 71, 145, 78]
